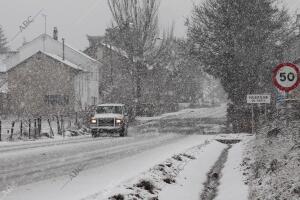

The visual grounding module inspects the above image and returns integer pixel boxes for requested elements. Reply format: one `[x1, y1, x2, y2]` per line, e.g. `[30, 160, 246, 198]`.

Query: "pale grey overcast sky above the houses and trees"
[0, 0, 300, 50]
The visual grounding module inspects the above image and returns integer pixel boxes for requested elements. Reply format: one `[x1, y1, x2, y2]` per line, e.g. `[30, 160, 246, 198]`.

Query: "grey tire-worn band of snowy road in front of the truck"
[0, 134, 183, 190]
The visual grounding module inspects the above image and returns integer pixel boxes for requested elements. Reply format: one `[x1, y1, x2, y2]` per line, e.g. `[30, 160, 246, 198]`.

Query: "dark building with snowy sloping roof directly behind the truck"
[84, 35, 135, 105]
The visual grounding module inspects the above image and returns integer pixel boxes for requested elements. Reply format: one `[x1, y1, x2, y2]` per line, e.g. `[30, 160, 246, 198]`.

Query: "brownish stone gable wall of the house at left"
[8, 52, 78, 116]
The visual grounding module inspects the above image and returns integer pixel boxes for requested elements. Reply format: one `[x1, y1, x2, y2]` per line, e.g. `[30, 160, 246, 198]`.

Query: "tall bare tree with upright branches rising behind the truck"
[108, 0, 173, 115]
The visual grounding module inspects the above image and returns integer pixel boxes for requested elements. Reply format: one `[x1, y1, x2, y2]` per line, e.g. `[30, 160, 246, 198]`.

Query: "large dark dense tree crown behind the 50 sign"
[188, 0, 289, 105]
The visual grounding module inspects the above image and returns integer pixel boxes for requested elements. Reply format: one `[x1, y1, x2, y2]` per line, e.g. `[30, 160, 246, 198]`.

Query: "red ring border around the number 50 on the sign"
[272, 63, 300, 92]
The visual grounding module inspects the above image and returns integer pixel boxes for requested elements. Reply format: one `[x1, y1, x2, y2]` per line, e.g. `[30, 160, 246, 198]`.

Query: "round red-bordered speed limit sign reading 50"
[272, 63, 300, 92]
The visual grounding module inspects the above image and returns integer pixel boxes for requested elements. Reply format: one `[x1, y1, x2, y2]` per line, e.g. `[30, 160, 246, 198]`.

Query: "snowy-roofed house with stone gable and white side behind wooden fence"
[2, 31, 102, 115]
